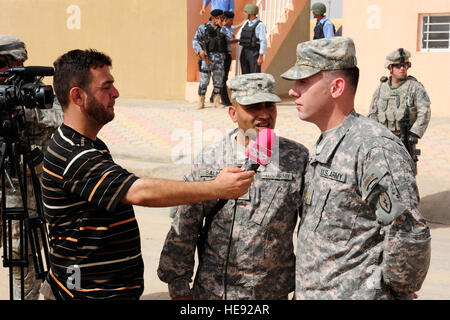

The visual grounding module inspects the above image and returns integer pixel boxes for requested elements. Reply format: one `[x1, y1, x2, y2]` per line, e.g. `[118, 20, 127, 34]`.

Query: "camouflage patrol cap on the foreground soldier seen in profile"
[281, 37, 356, 80]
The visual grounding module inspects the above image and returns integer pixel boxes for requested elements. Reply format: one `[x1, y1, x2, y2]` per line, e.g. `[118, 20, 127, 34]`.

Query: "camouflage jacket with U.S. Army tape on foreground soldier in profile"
[295, 111, 431, 299]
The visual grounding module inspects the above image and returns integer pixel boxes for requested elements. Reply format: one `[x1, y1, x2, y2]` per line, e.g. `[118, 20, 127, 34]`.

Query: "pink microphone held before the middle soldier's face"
[244, 128, 277, 171]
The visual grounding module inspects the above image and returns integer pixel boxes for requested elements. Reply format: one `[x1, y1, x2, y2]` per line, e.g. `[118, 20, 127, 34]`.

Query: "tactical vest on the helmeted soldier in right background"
[374, 76, 417, 136]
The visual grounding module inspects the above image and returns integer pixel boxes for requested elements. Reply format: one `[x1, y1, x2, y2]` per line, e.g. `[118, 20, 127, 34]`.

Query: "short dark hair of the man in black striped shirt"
[53, 49, 112, 109]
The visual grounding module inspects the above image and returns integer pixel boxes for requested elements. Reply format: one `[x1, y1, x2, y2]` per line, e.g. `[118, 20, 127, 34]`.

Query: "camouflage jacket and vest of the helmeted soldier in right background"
[368, 76, 431, 138]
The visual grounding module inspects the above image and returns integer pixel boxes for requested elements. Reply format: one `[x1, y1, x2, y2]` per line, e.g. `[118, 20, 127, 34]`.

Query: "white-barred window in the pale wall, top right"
[420, 15, 450, 51]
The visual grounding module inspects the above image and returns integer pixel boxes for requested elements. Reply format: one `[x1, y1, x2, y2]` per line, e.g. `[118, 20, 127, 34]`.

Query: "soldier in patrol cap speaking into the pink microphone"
[158, 73, 308, 300]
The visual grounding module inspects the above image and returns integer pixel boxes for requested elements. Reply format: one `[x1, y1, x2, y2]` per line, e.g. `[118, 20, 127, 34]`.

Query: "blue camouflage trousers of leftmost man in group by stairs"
[198, 52, 225, 96]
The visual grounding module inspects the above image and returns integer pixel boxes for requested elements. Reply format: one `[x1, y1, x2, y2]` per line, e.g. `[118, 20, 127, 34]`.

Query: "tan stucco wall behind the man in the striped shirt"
[0, 0, 186, 100]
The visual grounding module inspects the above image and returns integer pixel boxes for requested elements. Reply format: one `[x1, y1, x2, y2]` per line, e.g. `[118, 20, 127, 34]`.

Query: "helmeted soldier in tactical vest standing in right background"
[368, 48, 431, 172]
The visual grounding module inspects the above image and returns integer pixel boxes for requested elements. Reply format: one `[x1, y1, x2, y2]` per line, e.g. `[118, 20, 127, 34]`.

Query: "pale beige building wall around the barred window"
[343, 0, 450, 117]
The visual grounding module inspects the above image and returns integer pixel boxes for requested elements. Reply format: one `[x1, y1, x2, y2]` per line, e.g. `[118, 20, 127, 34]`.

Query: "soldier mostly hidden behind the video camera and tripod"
[0, 34, 63, 300]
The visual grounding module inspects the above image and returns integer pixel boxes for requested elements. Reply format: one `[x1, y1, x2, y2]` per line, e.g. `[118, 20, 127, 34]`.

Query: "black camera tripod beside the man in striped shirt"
[0, 138, 49, 300]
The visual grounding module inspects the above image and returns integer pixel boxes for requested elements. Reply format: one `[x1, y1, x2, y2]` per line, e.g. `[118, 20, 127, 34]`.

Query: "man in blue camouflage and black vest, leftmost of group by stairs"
[192, 9, 234, 109]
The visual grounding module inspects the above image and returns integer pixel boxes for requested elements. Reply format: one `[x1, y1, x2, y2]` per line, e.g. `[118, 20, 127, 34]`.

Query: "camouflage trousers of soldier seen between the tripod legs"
[0, 179, 42, 300]
